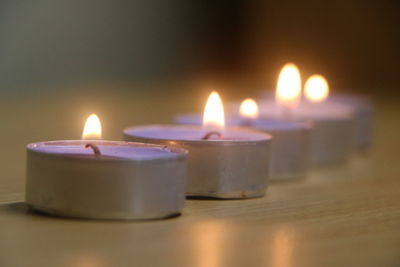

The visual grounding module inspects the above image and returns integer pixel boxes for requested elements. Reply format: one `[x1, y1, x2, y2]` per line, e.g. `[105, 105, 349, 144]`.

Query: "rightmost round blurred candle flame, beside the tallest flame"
[304, 74, 329, 102]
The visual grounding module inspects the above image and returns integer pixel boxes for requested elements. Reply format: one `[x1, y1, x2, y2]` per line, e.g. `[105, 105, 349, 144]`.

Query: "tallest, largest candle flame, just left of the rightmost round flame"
[276, 63, 301, 108]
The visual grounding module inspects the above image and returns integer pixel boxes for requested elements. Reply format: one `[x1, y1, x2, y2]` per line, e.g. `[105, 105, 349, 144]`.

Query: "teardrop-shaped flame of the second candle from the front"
[203, 91, 225, 128]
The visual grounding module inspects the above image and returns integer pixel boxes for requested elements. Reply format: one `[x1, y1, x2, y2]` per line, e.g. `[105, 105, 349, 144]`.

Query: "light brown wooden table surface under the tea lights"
[0, 87, 400, 267]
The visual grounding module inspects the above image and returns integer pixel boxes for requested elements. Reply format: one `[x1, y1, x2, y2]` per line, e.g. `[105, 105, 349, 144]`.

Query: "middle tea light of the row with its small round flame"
[175, 99, 311, 181]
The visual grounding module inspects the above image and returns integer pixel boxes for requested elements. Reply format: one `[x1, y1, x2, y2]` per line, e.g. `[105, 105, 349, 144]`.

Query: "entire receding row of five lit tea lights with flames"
[26, 64, 373, 219]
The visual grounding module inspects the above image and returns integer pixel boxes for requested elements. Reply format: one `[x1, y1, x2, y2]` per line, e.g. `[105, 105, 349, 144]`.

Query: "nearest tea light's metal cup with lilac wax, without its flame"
[26, 140, 187, 220]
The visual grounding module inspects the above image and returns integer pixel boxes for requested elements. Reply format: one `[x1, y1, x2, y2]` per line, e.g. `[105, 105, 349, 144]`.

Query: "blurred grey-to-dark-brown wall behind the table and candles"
[0, 0, 400, 95]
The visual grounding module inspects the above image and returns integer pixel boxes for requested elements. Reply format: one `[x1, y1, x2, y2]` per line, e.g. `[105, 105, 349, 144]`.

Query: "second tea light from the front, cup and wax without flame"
[124, 125, 271, 198]
